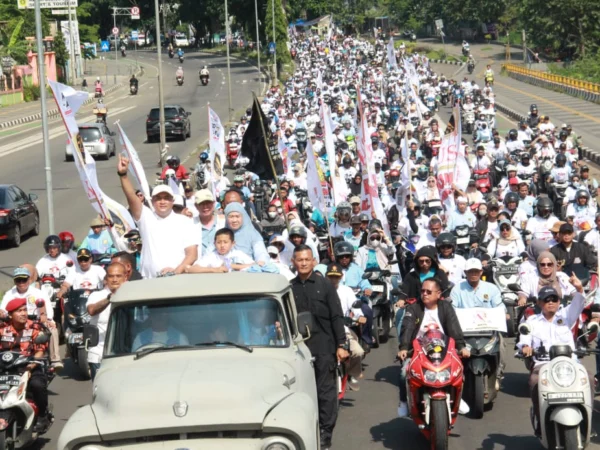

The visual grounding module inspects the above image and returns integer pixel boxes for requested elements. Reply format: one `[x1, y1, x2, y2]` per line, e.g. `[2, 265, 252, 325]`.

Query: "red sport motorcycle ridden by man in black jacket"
[406, 330, 463, 450]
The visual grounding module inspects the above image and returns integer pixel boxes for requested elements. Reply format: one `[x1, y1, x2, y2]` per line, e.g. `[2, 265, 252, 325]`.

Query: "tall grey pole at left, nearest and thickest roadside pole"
[35, 0, 54, 234]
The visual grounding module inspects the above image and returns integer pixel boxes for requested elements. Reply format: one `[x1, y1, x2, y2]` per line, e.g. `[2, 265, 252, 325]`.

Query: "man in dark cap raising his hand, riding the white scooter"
[517, 275, 594, 436]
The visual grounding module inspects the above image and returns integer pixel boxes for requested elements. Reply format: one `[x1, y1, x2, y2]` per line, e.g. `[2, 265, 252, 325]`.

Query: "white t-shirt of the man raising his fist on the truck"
[138, 206, 201, 278]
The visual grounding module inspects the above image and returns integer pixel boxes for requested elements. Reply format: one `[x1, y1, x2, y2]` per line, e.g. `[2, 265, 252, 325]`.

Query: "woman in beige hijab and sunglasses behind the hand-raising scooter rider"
[519, 250, 575, 306]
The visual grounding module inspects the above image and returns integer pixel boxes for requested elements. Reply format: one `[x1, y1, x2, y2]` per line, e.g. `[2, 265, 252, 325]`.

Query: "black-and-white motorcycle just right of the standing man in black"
[363, 270, 394, 348]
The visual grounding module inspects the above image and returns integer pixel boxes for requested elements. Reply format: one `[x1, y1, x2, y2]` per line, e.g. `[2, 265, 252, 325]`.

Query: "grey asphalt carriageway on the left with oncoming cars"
[0, 52, 263, 292]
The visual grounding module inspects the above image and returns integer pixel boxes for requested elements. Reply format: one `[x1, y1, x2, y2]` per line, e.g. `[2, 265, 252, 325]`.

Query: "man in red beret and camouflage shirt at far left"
[0, 298, 49, 431]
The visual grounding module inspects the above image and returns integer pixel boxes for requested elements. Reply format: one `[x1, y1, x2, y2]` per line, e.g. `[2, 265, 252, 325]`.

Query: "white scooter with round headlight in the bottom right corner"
[519, 322, 598, 450]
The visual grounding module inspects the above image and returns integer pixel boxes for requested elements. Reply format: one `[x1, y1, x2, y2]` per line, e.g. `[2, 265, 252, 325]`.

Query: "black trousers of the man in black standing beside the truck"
[314, 354, 338, 441]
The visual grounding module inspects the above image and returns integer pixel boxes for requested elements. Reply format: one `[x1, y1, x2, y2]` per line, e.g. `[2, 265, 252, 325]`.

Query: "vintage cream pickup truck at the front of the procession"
[56, 272, 319, 450]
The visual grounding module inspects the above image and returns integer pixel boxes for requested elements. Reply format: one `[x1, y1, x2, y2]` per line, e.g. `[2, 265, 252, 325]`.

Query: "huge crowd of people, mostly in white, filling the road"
[0, 29, 600, 449]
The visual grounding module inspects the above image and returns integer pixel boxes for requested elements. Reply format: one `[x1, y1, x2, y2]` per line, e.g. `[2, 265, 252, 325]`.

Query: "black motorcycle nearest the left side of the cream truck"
[64, 289, 93, 380]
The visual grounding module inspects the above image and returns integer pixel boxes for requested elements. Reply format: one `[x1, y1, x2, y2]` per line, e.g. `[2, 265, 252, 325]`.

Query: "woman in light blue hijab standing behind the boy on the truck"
[225, 202, 271, 263]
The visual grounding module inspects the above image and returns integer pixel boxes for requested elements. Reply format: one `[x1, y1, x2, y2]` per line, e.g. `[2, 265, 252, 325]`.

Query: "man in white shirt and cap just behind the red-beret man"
[0, 264, 63, 371]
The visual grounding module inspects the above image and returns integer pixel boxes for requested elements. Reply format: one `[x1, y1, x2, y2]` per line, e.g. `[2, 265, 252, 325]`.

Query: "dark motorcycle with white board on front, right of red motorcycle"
[457, 307, 506, 419]
